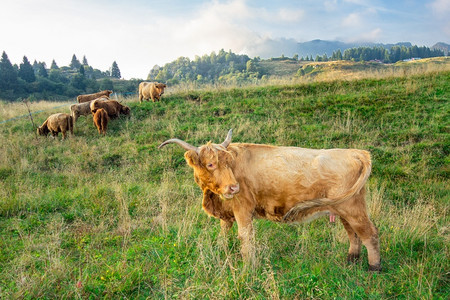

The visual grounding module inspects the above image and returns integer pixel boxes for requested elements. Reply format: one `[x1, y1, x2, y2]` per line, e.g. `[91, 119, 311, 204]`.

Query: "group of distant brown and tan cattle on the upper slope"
[37, 82, 167, 139]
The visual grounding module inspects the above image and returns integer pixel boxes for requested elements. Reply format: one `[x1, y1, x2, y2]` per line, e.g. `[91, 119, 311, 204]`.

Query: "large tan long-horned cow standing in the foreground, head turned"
[159, 130, 381, 271]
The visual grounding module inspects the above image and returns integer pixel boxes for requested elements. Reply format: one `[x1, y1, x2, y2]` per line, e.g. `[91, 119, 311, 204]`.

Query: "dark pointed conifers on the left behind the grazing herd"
[0, 51, 127, 101]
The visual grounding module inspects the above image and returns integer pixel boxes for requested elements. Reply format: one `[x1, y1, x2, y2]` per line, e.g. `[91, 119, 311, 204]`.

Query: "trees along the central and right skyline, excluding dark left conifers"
[147, 46, 444, 85]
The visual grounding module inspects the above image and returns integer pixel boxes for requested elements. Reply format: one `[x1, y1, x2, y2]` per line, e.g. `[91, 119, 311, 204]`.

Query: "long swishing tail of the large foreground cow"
[283, 151, 372, 222]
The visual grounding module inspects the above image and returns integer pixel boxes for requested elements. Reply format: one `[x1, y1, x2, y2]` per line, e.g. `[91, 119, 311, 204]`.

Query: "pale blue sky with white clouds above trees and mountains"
[0, 0, 450, 79]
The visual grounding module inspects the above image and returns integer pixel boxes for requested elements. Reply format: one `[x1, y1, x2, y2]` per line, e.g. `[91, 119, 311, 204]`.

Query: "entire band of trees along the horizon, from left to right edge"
[0, 46, 444, 101]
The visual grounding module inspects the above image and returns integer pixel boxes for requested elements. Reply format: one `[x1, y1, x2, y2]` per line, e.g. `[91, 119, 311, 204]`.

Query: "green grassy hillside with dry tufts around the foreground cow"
[0, 72, 450, 299]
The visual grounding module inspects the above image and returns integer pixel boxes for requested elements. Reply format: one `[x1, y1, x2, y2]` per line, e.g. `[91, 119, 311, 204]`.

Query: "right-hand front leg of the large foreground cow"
[234, 212, 255, 263]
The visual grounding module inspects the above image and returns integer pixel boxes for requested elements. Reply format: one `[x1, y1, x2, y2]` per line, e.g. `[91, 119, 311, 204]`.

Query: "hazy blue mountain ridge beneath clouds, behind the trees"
[244, 39, 412, 58]
